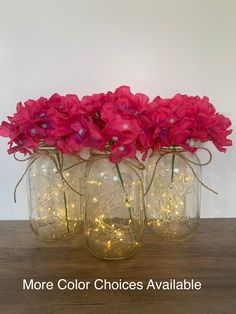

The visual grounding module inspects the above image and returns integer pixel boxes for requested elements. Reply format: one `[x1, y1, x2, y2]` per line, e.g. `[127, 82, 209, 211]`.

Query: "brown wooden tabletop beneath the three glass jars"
[0, 219, 236, 314]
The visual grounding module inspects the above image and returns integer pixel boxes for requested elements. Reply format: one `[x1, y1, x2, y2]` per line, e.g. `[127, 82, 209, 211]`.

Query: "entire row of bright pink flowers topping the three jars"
[0, 86, 232, 163]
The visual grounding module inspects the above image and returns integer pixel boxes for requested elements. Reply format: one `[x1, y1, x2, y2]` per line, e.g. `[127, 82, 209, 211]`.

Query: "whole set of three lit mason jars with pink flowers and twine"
[0, 86, 232, 253]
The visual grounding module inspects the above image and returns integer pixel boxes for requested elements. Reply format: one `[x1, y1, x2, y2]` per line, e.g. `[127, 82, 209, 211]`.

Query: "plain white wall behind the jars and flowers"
[0, 0, 236, 219]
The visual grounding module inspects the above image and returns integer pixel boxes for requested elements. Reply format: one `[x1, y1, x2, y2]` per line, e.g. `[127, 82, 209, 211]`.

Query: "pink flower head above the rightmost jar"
[149, 94, 232, 152]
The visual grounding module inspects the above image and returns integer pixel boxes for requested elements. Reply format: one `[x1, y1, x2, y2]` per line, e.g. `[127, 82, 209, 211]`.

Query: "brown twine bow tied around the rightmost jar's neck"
[144, 147, 218, 196]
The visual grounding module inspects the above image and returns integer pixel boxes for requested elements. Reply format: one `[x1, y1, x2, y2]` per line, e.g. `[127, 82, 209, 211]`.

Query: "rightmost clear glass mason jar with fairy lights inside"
[145, 148, 201, 241]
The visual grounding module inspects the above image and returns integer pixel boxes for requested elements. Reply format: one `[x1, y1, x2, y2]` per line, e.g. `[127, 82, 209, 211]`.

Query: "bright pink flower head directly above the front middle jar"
[101, 86, 149, 162]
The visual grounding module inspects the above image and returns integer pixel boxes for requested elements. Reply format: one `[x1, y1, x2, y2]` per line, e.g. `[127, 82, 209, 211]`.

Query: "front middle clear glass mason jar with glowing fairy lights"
[84, 157, 144, 259]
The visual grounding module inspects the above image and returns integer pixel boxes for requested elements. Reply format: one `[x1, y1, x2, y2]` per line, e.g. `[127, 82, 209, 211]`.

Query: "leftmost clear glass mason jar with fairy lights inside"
[27, 147, 83, 241]
